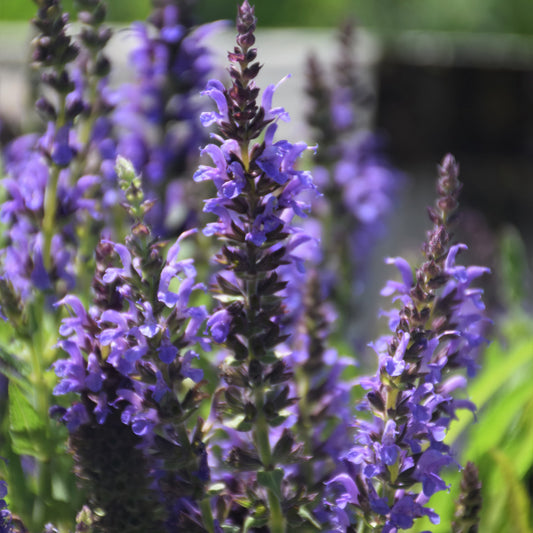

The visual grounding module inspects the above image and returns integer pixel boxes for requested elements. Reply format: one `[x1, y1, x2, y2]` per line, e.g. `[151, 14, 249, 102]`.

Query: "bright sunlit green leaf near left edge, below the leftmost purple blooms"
[9, 383, 47, 459]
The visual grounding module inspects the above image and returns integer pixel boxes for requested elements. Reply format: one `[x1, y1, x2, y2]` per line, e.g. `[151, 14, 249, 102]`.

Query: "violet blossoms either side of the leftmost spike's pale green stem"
[0, 135, 99, 301]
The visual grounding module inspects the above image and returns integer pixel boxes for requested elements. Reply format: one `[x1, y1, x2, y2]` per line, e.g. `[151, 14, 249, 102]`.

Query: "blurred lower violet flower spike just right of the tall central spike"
[289, 271, 354, 498]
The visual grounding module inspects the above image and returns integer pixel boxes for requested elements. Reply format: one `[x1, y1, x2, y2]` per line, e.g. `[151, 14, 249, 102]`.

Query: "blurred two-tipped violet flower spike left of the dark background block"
[307, 24, 402, 340]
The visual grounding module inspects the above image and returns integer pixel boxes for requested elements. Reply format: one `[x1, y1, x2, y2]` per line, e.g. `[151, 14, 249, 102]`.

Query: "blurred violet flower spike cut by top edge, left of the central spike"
[114, 0, 218, 235]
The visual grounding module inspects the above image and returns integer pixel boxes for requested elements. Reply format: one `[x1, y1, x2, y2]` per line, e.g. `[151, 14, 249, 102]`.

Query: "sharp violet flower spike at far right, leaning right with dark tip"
[330, 155, 488, 532]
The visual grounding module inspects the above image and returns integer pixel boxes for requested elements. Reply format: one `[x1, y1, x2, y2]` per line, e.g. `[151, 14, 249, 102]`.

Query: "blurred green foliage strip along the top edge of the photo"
[0, 0, 533, 34]
